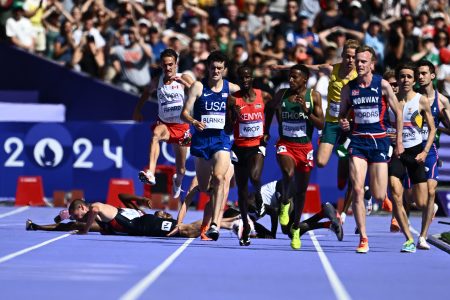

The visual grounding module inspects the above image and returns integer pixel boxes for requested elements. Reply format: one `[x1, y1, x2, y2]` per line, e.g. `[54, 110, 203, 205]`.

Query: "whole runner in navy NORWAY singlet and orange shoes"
[339, 46, 403, 253]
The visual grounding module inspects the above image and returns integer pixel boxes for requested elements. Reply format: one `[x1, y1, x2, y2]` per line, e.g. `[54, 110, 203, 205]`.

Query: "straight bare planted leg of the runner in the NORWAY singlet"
[350, 156, 367, 238]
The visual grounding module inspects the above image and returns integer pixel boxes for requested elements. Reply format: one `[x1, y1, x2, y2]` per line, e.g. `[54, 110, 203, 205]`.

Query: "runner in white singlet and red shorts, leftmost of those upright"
[133, 49, 193, 198]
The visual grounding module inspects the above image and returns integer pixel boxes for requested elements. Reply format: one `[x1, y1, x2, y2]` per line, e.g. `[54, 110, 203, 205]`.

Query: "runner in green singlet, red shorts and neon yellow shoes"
[265, 65, 324, 249]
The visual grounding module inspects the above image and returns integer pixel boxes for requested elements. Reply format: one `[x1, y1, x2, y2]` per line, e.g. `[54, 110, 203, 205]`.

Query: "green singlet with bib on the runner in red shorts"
[278, 89, 314, 144]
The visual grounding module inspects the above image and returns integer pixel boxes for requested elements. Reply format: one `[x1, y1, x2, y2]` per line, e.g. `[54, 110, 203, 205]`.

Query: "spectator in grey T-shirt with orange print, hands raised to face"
[111, 27, 152, 94]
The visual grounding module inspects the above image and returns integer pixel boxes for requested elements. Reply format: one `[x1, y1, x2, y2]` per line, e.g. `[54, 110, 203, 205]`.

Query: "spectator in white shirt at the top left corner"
[6, 2, 36, 52]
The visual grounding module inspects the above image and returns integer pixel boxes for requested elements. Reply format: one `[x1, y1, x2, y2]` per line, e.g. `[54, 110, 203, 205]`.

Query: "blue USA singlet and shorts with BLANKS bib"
[191, 79, 231, 160]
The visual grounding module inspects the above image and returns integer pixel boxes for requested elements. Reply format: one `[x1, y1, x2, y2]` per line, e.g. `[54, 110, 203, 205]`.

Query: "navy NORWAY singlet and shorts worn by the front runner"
[348, 75, 390, 163]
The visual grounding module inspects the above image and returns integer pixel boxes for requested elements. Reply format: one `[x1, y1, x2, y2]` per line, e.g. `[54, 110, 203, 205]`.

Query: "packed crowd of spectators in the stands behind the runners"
[0, 0, 450, 97]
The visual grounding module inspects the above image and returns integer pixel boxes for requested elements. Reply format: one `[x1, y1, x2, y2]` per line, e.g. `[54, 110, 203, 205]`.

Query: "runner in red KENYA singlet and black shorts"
[227, 66, 272, 246]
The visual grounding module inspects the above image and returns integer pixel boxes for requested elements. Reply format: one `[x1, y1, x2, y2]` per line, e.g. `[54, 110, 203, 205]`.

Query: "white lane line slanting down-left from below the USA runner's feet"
[120, 238, 194, 300]
